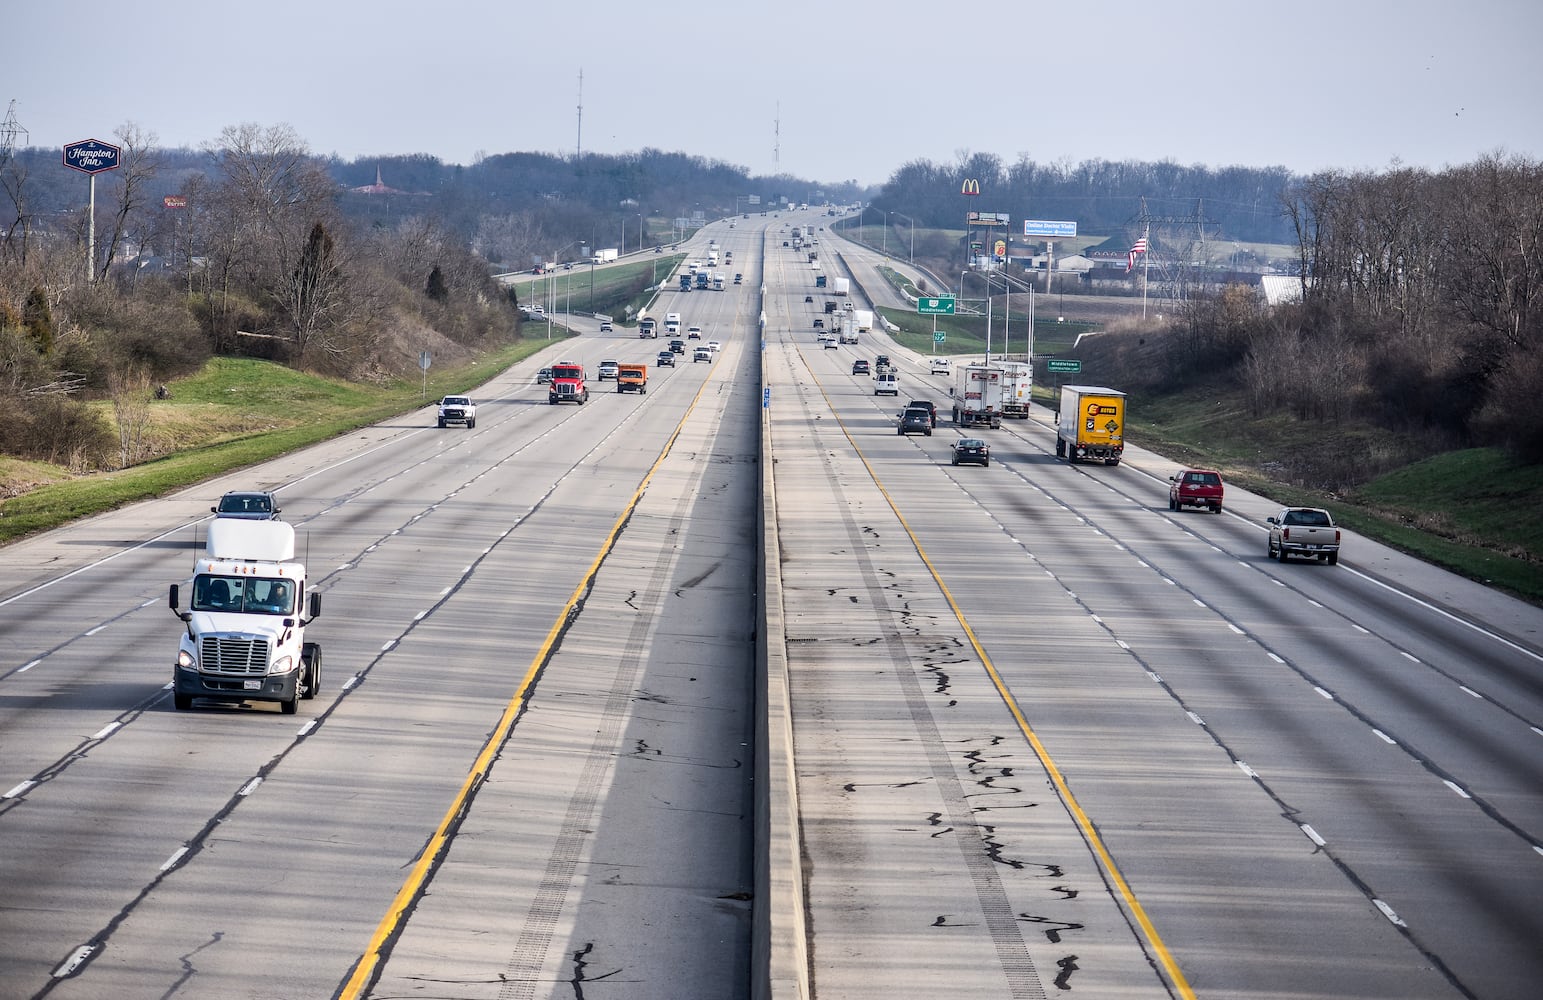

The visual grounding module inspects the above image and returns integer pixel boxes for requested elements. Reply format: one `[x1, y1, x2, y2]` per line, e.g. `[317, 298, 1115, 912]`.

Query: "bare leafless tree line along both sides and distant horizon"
[0, 123, 1543, 481]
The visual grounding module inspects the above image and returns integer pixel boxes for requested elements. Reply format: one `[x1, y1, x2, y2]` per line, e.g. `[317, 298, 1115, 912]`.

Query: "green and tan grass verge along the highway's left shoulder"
[0, 330, 568, 545]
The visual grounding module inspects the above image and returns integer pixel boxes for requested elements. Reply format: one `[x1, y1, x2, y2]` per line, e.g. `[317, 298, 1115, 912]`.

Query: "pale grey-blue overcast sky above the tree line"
[12, 0, 1543, 184]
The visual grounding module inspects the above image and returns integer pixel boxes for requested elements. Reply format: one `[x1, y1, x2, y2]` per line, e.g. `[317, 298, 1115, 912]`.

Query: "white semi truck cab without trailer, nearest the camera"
[168, 517, 321, 715]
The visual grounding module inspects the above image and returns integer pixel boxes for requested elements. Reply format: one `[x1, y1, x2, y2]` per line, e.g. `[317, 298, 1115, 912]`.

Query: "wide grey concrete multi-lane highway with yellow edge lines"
[0, 211, 1543, 1000]
